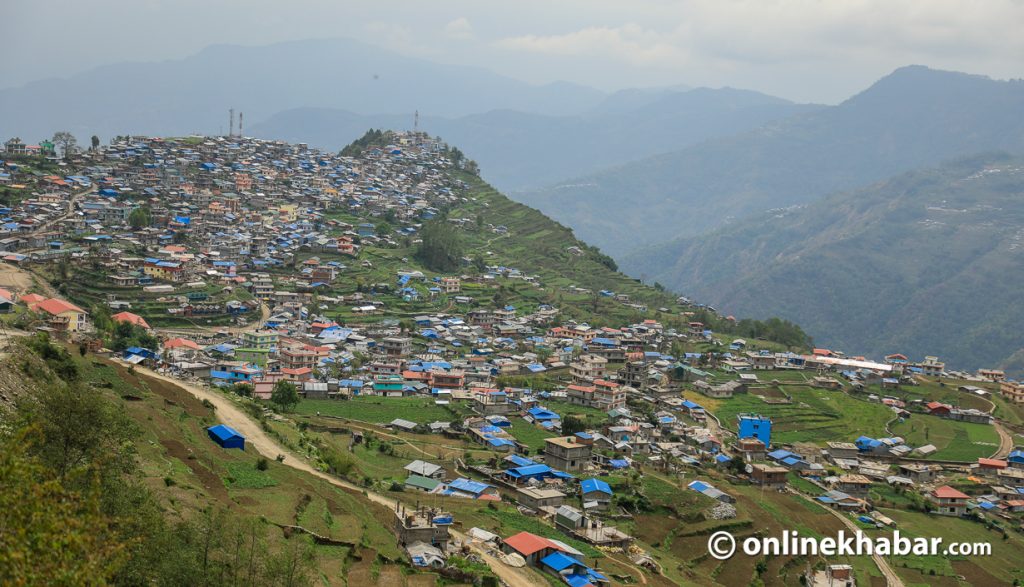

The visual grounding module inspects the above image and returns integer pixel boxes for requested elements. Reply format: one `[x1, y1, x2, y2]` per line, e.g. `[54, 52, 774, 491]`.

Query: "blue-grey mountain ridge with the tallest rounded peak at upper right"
[513, 66, 1024, 255]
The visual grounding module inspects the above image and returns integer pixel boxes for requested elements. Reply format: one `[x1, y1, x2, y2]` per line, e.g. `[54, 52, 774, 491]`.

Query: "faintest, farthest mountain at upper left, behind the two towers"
[0, 39, 607, 141]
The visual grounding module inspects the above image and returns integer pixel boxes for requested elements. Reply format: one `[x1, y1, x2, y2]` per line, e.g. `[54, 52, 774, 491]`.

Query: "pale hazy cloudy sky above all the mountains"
[0, 0, 1024, 102]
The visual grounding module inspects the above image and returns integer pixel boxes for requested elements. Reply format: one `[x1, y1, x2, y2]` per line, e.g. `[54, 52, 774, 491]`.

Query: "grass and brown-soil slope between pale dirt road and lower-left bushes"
[29, 349, 433, 586]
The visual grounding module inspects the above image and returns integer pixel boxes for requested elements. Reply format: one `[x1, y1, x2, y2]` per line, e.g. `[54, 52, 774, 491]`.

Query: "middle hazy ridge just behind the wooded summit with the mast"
[249, 88, 821, 191]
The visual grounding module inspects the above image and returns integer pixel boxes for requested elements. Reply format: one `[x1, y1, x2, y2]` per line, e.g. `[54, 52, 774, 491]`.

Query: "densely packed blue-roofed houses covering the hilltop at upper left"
[0, 133, 471, 316]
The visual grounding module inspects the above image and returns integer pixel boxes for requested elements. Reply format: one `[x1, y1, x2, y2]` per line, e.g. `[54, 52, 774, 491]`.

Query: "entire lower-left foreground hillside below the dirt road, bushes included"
[0, 337, 415, 586]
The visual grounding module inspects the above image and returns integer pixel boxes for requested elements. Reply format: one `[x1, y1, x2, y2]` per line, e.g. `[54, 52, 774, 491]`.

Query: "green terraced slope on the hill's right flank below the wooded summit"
[315, 173, 696, 326]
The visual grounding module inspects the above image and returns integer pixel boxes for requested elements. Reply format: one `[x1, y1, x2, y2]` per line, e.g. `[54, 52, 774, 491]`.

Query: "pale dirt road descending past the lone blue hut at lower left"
[135, 366, 549, 587]
